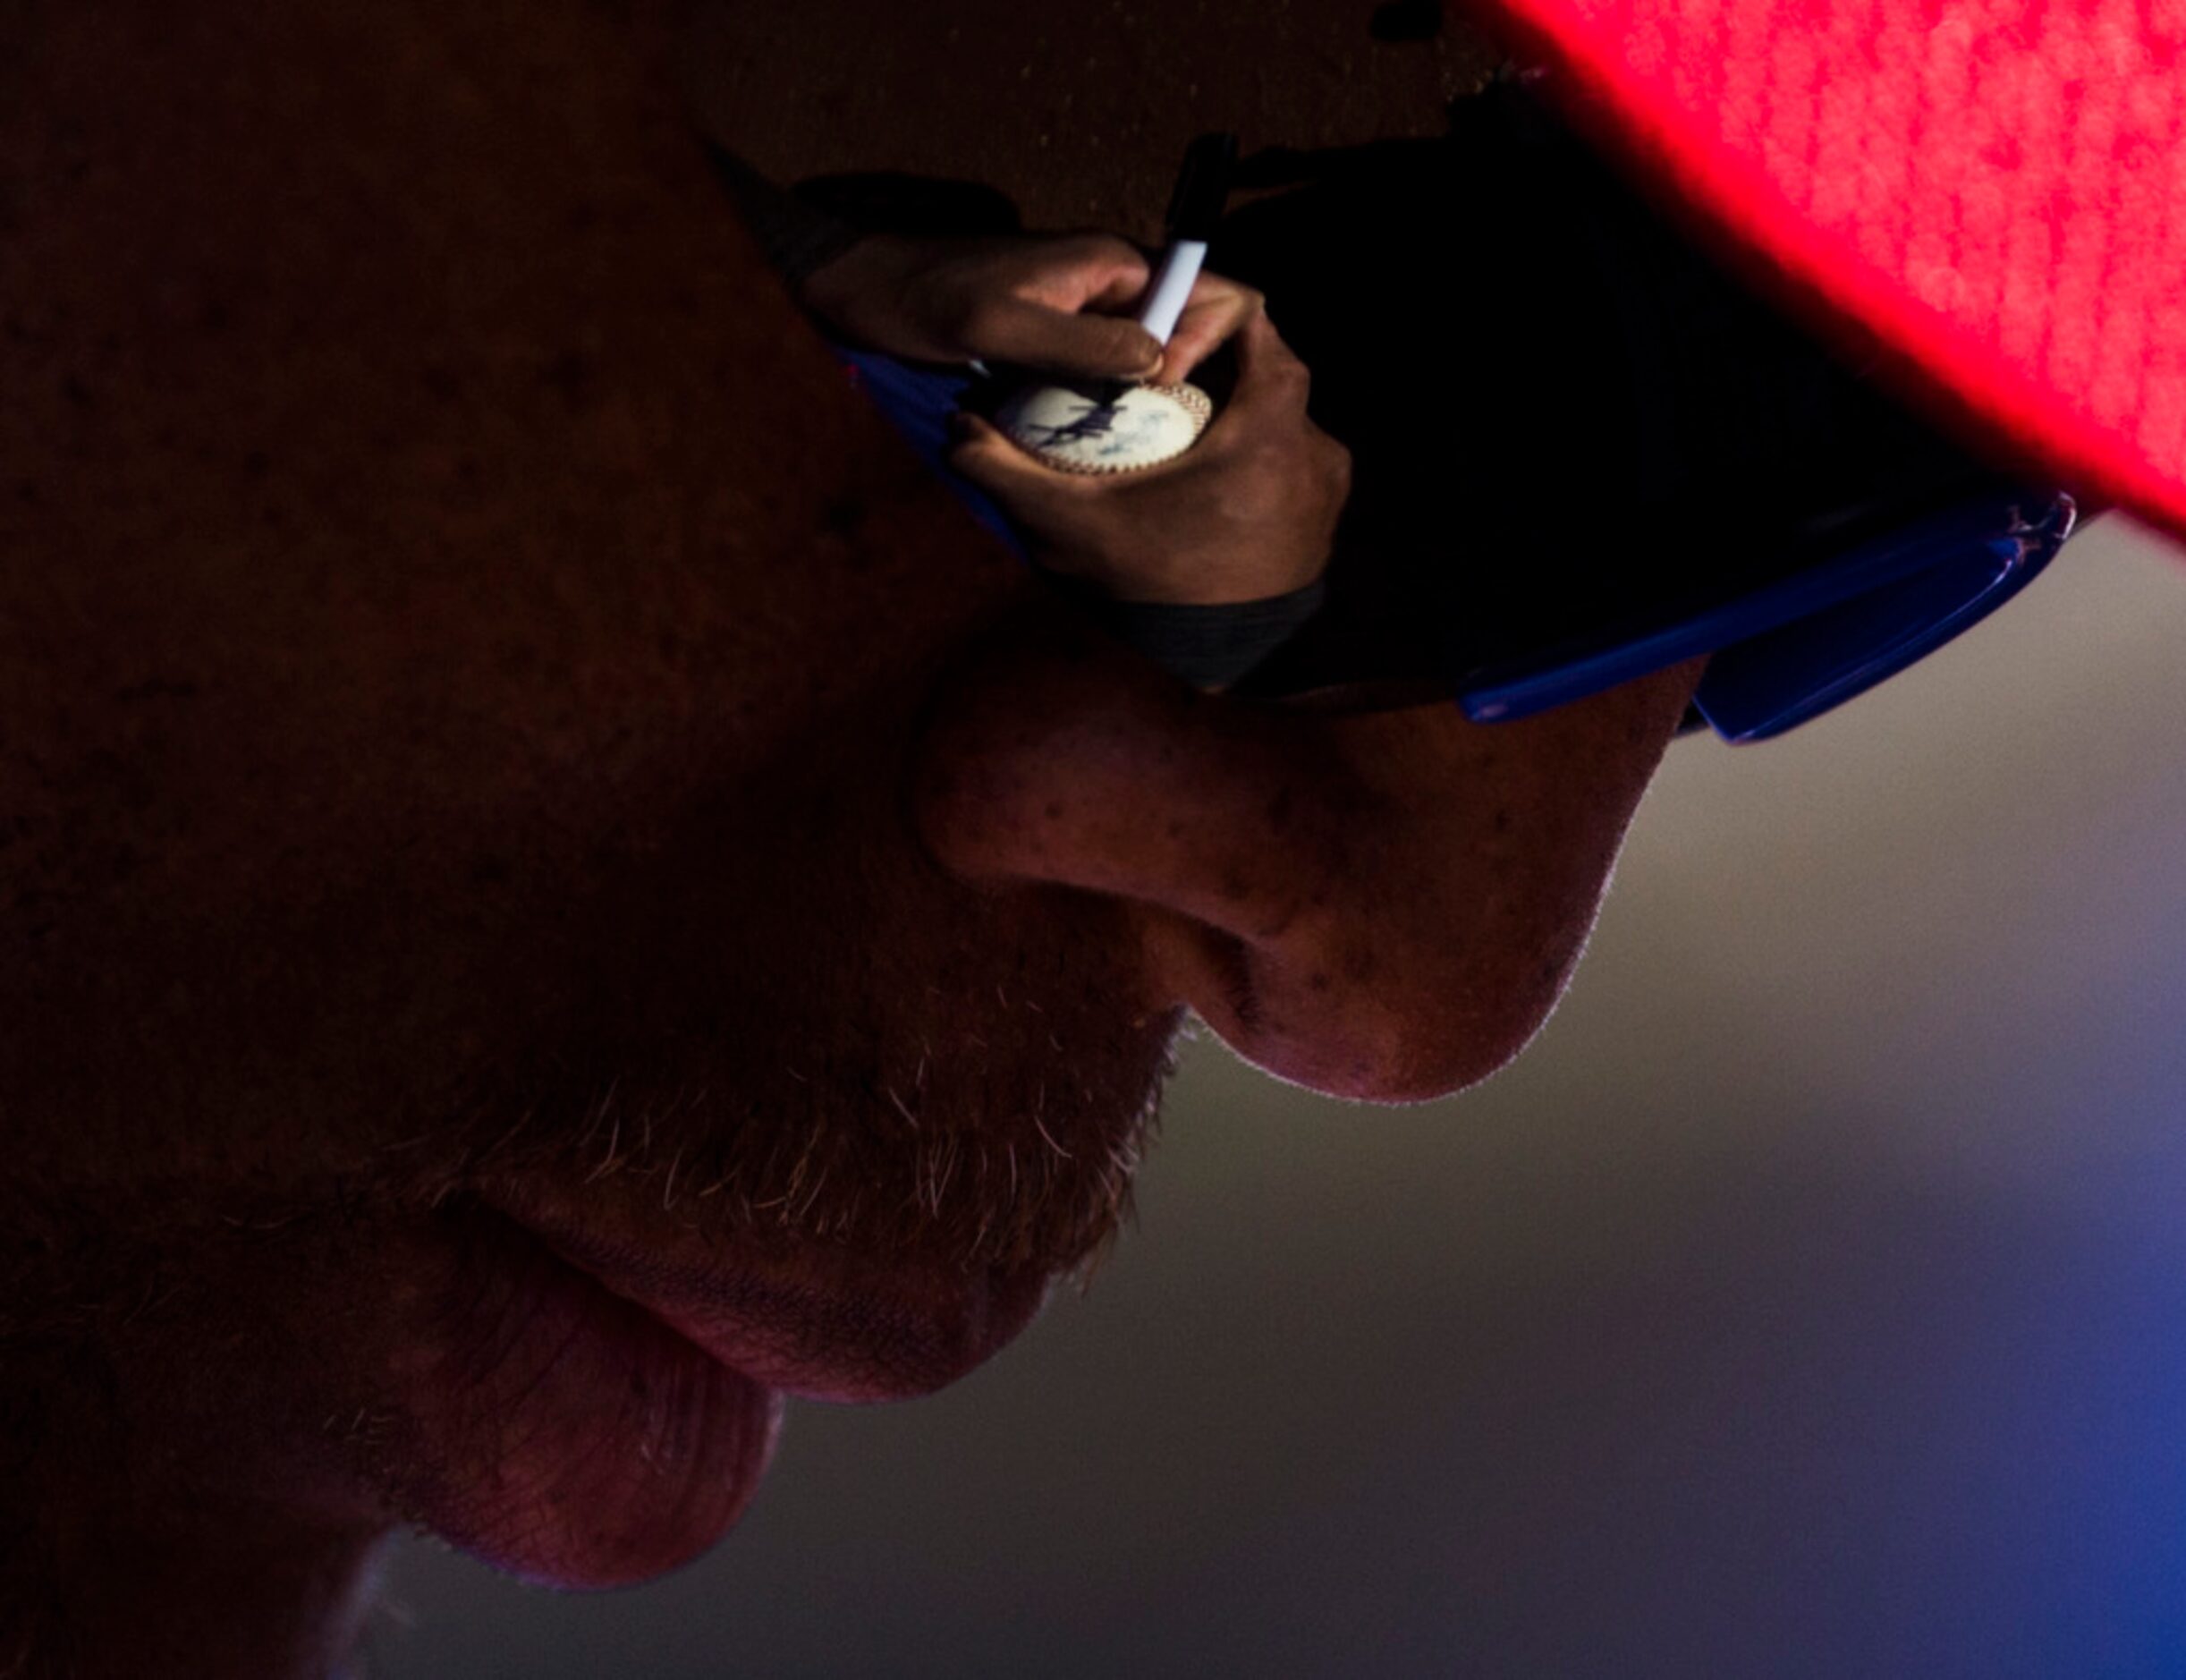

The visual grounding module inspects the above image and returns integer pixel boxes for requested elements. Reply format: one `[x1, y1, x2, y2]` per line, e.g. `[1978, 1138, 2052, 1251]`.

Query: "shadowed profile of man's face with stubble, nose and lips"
[0, 4, 1692, 1674]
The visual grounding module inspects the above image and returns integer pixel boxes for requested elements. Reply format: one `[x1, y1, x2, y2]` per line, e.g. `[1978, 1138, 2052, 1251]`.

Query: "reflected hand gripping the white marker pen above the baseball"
[801, 234, 1259, 380]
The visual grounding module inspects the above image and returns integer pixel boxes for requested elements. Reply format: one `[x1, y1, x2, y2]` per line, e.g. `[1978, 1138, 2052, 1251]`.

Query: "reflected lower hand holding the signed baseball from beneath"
[949, 300, 1351, 606]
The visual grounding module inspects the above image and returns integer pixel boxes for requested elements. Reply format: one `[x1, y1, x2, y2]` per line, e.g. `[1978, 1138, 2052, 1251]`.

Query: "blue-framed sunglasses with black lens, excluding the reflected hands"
[835, 59, 2079, 742]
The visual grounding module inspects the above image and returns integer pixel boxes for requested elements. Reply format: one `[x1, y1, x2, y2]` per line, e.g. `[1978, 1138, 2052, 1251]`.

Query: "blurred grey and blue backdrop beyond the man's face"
[368, 514, 2186, 1680]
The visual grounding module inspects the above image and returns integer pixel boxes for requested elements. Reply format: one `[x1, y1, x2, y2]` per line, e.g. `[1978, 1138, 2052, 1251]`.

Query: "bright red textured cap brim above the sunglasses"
[1491, 0, 2186, 536]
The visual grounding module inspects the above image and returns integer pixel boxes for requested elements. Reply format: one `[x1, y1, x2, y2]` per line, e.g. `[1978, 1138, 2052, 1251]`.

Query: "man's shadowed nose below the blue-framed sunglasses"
[914, 604, 1699, 1102]
